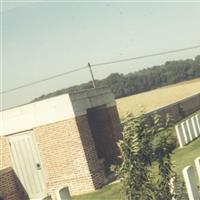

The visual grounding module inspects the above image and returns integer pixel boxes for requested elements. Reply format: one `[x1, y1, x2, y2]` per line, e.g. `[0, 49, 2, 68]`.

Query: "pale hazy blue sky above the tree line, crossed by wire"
[1, 0, 200, 108]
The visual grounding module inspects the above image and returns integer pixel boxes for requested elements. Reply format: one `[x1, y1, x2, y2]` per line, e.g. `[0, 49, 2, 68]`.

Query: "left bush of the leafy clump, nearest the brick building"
[113, 114, 153, 200]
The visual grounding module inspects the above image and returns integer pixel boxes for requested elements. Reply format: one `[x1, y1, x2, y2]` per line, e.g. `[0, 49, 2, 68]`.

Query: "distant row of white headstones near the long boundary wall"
[175, 114, 200, 148]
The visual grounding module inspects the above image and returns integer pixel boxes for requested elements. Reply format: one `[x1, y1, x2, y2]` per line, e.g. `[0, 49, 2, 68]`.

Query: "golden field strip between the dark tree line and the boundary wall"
[117, 78, 200, 117]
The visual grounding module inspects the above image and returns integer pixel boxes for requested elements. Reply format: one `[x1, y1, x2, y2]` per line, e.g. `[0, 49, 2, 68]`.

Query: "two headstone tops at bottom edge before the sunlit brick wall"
[40, 187, 71, 200]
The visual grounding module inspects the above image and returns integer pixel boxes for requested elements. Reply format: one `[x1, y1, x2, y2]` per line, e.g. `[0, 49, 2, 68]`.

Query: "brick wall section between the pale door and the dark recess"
[34, 116, 104, 194]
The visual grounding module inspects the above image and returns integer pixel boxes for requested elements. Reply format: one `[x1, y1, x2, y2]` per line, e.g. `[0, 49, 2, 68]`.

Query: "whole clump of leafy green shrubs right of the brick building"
[113, 114, 177, 200]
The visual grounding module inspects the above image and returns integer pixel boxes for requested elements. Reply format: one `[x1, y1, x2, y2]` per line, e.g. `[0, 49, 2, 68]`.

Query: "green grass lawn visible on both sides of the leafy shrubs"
[72, 138, 200, 200]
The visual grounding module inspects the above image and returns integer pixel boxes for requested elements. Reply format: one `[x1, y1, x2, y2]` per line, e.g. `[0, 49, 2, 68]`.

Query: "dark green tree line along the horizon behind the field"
[32, 55, 200, 102]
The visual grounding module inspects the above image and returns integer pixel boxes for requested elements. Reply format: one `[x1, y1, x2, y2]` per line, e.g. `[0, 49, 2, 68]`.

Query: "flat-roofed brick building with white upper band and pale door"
[0, 88, 121, 200]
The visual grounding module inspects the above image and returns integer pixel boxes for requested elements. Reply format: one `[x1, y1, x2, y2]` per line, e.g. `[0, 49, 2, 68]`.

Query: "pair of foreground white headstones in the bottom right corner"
[183, 157, 200, 200]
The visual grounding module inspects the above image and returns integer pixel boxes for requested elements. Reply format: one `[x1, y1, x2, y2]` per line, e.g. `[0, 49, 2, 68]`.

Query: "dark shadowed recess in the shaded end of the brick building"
[88, 106, 122, 172]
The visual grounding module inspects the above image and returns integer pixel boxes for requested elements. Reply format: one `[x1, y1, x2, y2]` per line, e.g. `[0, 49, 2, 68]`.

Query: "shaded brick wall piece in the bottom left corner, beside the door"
[0, 167, 28, 200]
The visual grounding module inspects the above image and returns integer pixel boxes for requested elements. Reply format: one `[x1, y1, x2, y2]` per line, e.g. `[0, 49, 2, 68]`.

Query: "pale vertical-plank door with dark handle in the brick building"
[9, 131, 46, 199]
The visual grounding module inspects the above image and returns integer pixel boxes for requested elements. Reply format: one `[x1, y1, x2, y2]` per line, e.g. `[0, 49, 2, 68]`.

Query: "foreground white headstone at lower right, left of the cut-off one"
[183, 166, 200, 200]
